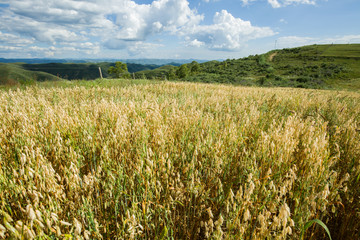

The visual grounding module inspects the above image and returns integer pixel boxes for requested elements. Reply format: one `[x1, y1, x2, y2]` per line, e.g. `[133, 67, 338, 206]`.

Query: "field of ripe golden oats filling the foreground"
[0, 80, 360, 239]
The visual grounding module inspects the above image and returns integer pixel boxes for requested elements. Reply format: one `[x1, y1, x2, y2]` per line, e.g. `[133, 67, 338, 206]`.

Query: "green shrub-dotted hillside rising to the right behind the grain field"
[139, 44, 360, 89]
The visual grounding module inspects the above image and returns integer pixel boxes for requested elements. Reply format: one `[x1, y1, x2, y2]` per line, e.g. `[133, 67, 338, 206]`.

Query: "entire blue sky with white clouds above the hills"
[0, 0, 360, 60]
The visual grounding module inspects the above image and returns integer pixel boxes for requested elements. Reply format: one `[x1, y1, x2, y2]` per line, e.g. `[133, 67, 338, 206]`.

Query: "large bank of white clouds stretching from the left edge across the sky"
[0, 0, 276, 55]
